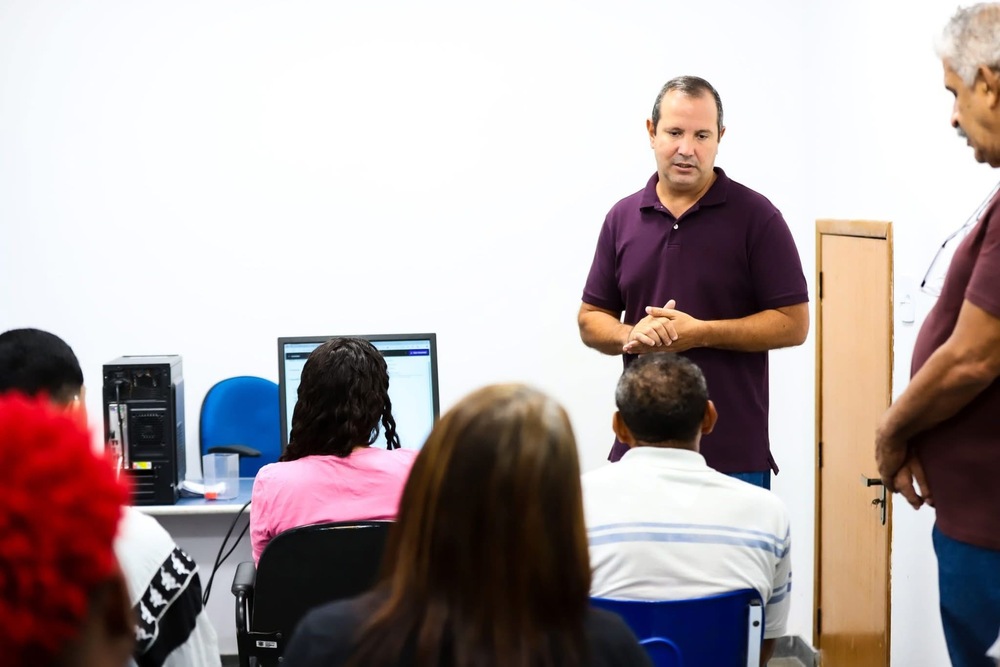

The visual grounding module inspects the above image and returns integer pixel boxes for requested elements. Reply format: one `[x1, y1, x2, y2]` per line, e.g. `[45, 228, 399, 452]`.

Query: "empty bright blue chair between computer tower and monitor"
[198, 375, 281, 477]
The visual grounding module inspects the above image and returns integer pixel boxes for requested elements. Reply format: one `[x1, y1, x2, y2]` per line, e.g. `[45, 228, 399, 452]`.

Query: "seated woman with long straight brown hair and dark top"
[283, 384, 649, 667]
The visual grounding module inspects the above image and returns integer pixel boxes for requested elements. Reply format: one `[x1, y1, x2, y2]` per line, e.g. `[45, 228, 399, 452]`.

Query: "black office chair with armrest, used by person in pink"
[232, 521, 392, 667]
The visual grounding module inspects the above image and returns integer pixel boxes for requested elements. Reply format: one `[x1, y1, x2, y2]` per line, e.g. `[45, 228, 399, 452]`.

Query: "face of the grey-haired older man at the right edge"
[944, 63, 1000, 167]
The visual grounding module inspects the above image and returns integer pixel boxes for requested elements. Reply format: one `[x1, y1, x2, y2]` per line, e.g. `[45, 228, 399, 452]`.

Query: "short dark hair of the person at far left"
[0, 329, 83, 403]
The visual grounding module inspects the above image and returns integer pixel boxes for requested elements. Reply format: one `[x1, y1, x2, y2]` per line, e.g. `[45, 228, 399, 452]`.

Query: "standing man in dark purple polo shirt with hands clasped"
[578, 76, 809, 488]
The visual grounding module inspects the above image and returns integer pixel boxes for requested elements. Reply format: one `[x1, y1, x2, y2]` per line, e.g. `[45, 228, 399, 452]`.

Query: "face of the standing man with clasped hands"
[646, 90, 725, 194]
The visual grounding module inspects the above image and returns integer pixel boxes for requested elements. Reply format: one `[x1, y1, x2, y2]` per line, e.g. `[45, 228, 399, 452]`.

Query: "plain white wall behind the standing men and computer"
[0, 0, 992, 664]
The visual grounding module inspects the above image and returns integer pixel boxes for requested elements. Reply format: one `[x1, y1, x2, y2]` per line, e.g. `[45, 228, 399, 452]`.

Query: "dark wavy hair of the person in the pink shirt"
[281, 338, 399, 461]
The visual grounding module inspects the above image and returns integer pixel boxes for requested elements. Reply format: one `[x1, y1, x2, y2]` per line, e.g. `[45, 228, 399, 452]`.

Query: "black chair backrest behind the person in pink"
[250, 521, 392, 637]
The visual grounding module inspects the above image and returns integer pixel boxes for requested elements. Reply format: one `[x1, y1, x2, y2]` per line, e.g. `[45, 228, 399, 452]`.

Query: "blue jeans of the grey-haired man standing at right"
[932, 526, 1000, 667]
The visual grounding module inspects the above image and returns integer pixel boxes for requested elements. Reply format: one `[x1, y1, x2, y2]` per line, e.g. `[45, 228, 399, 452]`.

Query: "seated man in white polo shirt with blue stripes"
[583, 353, 792, 665]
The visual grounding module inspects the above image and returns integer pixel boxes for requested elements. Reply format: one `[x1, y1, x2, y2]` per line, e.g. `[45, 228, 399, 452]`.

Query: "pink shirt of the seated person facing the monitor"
[250, 447, 418, 563]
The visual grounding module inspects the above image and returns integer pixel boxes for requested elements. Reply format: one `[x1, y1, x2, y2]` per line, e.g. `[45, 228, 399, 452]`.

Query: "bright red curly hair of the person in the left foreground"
[0, 394, 128, 665]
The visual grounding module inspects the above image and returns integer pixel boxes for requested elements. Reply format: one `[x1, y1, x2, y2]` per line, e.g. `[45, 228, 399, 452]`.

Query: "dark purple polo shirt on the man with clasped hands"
[583, 172, 809, 473]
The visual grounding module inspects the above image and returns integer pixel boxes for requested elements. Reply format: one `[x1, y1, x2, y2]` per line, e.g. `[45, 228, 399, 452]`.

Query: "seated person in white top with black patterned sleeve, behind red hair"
[0, 329, 222, 667]
